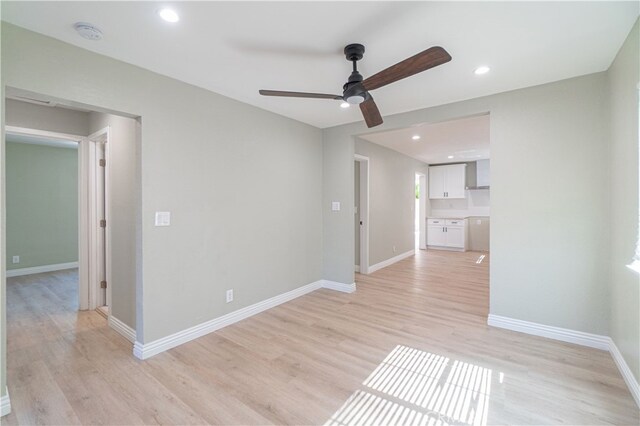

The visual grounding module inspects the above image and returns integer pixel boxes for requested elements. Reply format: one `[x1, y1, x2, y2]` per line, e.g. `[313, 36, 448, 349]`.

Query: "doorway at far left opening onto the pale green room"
[5, 126, 82, 320]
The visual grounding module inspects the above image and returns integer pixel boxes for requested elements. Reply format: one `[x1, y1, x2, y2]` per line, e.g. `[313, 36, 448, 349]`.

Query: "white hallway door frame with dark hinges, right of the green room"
[85, 126, 112, 316]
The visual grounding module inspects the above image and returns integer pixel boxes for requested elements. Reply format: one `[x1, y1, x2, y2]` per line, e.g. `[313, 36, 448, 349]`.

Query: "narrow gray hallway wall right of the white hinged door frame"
[89, 112, 140, 330]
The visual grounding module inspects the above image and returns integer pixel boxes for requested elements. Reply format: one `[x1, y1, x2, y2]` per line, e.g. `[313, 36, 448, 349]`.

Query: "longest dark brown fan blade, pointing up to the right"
[362, 46, 451, 90]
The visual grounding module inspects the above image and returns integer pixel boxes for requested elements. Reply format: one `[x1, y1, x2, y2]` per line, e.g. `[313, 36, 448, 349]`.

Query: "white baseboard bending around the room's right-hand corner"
[487, 314, 640, 407]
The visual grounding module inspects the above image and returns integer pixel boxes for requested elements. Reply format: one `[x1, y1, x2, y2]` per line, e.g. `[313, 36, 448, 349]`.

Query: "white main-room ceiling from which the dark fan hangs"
[2, 1, 639, 128]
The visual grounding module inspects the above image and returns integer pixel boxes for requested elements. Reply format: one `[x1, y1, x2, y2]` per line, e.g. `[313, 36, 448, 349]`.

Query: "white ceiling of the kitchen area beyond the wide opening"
[360, 115, 489, 164]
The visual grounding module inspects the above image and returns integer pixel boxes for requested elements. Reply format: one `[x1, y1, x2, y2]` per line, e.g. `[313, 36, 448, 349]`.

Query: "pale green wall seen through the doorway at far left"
[5, 141, 78, 270]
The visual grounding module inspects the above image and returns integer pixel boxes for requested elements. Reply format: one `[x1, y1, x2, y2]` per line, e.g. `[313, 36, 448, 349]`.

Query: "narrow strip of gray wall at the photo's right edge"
[608, 22, 640, 381]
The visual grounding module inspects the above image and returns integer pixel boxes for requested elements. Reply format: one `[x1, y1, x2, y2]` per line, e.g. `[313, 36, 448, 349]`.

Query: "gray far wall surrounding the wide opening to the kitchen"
[324, 73, 609, 334]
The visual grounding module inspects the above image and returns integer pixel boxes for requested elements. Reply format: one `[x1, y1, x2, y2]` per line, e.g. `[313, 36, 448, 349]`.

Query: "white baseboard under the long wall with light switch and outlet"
[133, 280, 356, 359]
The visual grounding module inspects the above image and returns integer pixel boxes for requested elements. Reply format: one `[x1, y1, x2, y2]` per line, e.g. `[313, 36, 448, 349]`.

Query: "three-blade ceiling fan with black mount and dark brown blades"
[260, 43, 451, 127]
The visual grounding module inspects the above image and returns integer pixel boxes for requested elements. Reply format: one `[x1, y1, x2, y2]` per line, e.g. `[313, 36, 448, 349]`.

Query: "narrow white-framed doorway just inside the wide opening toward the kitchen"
[354, 154, 369, 274]
